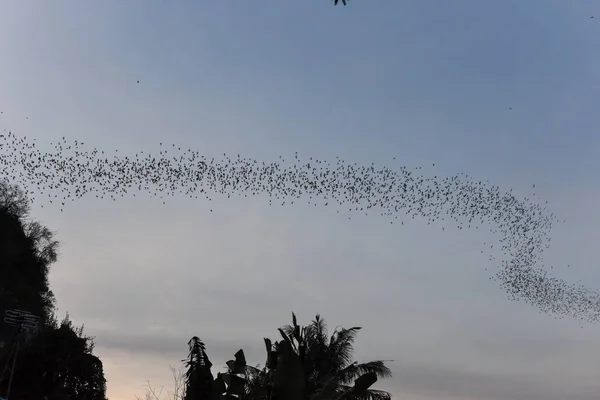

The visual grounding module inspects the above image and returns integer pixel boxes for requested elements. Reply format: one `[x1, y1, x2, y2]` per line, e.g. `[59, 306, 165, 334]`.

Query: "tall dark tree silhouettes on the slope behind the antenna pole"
[0, 182, 106, 400]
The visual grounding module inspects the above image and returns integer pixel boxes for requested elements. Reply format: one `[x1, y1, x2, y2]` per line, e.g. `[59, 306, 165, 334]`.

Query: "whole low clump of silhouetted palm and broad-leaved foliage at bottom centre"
[171, 314, 391, 400]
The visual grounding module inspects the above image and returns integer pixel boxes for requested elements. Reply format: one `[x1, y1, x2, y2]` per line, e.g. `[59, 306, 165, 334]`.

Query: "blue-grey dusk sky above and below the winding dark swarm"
[0, 0, 600, 400]
